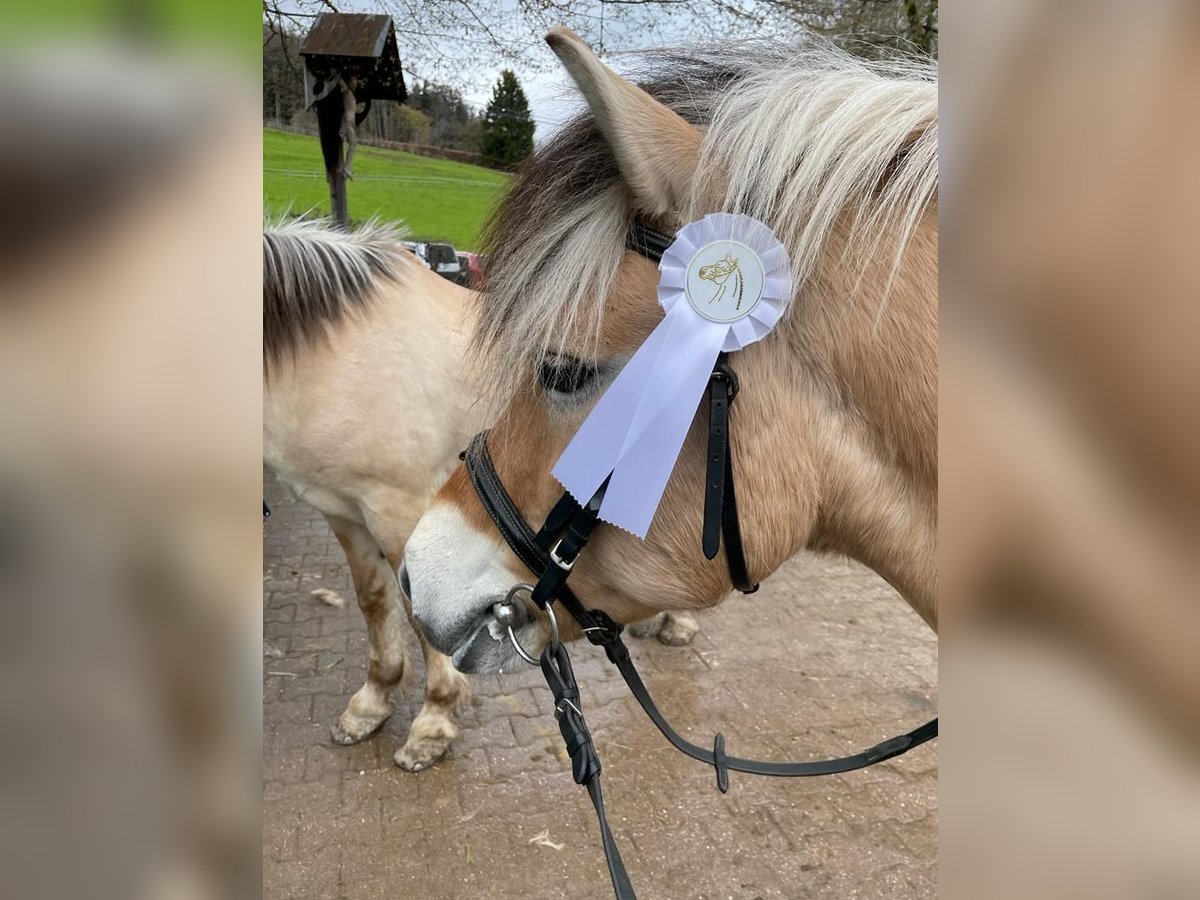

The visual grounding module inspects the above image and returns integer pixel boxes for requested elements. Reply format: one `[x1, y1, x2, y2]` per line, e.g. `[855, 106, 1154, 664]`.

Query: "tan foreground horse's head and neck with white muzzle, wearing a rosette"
[406, 30, 937, 671]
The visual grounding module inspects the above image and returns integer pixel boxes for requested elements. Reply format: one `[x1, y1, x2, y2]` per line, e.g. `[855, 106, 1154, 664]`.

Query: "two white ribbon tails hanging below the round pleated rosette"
[552, 304, 730, 538]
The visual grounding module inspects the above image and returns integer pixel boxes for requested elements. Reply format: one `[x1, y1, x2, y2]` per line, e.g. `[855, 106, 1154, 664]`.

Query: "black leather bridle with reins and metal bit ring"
[462, 223, 937, 900]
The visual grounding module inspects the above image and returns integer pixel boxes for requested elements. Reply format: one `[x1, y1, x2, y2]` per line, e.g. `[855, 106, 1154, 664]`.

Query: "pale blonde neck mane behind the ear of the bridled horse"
[691, 44, 937, 307]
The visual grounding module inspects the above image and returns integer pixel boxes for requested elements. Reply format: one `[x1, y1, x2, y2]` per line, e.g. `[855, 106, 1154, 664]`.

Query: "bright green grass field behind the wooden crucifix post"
[263, 128, 508, 250]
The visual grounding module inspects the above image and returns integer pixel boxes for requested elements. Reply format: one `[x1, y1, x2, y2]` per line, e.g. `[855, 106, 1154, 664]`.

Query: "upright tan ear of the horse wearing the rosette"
[546, 28, 701, 217]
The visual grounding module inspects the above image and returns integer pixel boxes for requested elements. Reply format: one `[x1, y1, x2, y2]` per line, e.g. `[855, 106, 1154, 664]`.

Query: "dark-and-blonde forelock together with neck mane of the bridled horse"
[476, 38, 937, 392]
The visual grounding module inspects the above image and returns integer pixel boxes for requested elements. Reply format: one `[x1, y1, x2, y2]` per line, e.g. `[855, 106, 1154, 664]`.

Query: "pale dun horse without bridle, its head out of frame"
[263, 220, 698, 772]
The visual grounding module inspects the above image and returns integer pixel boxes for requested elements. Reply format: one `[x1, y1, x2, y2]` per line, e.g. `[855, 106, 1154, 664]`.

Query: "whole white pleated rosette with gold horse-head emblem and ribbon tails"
[553, 212, 792, 538]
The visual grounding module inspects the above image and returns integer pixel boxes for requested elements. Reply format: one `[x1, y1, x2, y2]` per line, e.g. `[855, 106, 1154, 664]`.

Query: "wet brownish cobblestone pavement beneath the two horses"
[263, 479, 937, 900]
